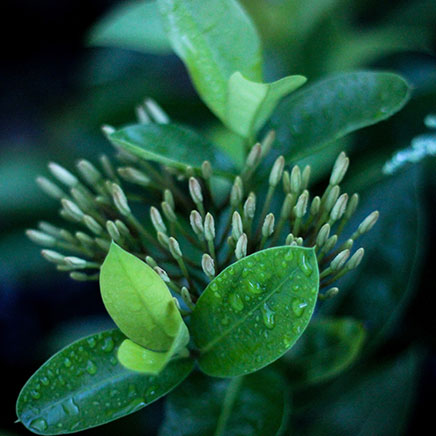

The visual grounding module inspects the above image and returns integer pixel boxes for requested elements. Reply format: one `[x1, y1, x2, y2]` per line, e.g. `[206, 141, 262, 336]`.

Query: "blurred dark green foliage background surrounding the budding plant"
[0, 0, 436, 436]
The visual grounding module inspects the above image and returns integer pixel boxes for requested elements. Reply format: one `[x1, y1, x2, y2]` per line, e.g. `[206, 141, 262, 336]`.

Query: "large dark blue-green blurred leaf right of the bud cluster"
[322, 167, 423, 346]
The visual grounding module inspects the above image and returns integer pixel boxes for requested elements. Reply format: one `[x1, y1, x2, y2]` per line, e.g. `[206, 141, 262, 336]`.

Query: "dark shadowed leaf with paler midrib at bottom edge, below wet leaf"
[160, 370, 289, 436]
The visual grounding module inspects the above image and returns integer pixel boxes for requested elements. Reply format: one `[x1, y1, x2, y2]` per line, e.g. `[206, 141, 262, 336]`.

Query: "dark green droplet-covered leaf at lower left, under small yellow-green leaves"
[17, 329, 193, 435]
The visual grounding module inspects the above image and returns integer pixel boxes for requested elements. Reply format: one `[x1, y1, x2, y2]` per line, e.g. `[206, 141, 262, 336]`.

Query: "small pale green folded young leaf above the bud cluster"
[225, 71, 307, 138]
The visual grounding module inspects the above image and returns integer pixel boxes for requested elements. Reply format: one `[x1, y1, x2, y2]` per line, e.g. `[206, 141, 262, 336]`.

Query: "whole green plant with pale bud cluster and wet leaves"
[17, 0, 409, 435]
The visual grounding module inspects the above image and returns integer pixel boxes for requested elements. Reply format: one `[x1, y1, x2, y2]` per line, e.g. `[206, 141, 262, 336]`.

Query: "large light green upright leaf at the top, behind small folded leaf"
[158, 0, 262, 120]
